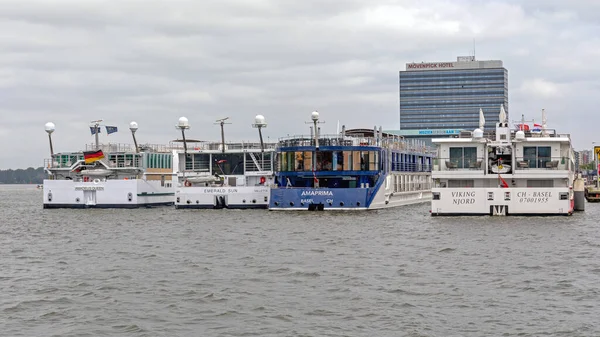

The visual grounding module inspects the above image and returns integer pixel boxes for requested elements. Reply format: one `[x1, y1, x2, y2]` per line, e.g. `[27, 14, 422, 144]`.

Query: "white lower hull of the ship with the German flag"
[43, 179, 175, 208]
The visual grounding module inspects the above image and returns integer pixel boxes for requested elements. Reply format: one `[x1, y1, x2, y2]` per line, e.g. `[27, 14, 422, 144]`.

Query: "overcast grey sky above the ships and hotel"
[0, 0, 600, 169]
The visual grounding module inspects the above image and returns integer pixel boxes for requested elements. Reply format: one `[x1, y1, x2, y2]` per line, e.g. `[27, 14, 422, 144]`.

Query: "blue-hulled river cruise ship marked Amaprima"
[269, 111, 433, 211]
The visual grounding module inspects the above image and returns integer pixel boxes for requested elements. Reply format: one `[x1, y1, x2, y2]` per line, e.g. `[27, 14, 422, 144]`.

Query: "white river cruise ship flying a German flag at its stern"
[42, 121, 176, 208]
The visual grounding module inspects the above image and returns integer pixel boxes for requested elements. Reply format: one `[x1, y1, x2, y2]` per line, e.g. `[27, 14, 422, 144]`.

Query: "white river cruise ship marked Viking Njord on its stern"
[431, 107, 575, 216]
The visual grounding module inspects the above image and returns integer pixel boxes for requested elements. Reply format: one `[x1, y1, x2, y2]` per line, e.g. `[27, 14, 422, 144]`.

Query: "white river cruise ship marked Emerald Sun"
[174, 115, 275, 209]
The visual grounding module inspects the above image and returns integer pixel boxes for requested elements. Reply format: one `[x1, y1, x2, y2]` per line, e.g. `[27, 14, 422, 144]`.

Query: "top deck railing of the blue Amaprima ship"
[277, 134, 437, 154]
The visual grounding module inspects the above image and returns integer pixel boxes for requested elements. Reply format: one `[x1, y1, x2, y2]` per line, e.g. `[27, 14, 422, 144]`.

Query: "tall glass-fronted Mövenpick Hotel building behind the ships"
[399, 56, 510, 134]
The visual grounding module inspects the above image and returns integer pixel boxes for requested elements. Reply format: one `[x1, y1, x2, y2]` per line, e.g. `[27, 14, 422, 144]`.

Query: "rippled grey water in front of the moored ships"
[0, 185, 600, 337]
